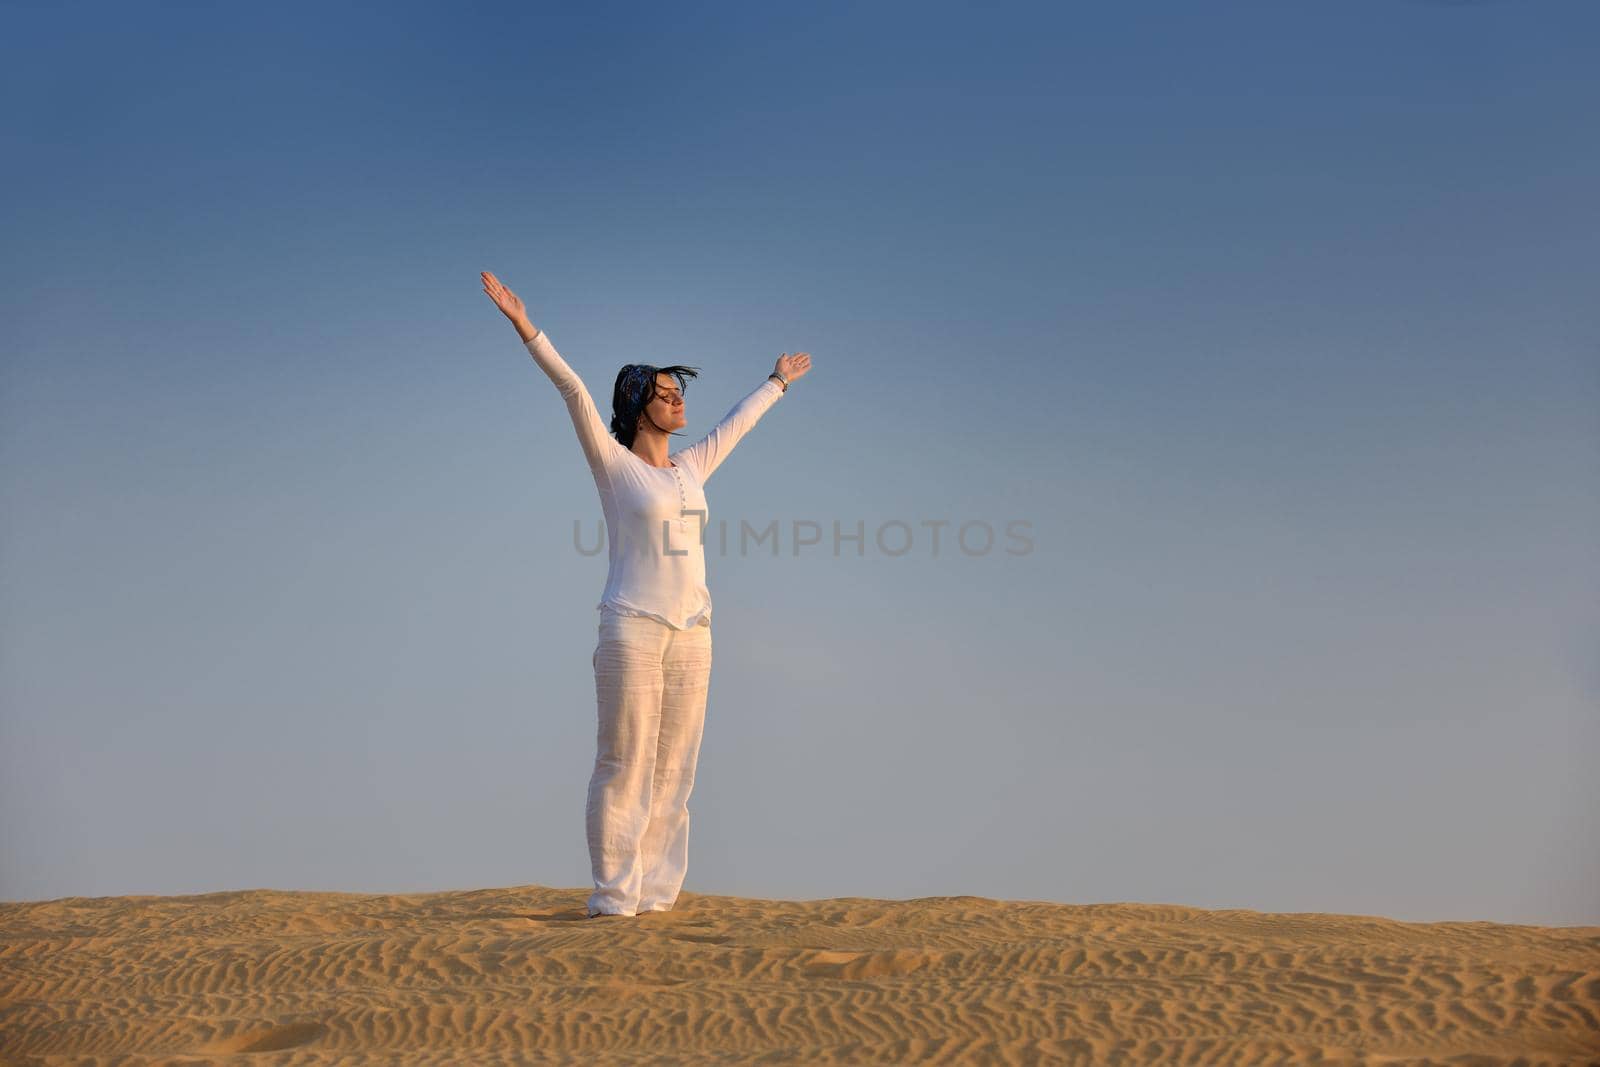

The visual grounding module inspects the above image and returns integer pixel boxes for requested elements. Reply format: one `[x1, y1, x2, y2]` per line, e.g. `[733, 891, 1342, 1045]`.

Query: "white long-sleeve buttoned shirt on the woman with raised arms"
[526, 330, 784, 630]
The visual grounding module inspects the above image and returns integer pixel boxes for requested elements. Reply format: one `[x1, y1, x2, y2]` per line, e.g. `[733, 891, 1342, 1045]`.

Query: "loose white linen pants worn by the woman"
[586, 609, 710, 915]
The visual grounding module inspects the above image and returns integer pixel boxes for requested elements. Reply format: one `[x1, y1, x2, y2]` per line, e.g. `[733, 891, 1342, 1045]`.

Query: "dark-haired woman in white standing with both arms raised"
[470, 270, 811, 918]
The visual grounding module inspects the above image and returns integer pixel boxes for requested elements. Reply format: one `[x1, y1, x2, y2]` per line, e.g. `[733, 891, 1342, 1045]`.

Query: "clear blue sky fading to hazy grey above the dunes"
[0, 0, 1600, 925]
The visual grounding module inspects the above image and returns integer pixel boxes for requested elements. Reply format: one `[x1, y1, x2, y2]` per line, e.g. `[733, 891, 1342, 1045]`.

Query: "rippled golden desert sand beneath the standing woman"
[0, 886, 1600, 1064]
